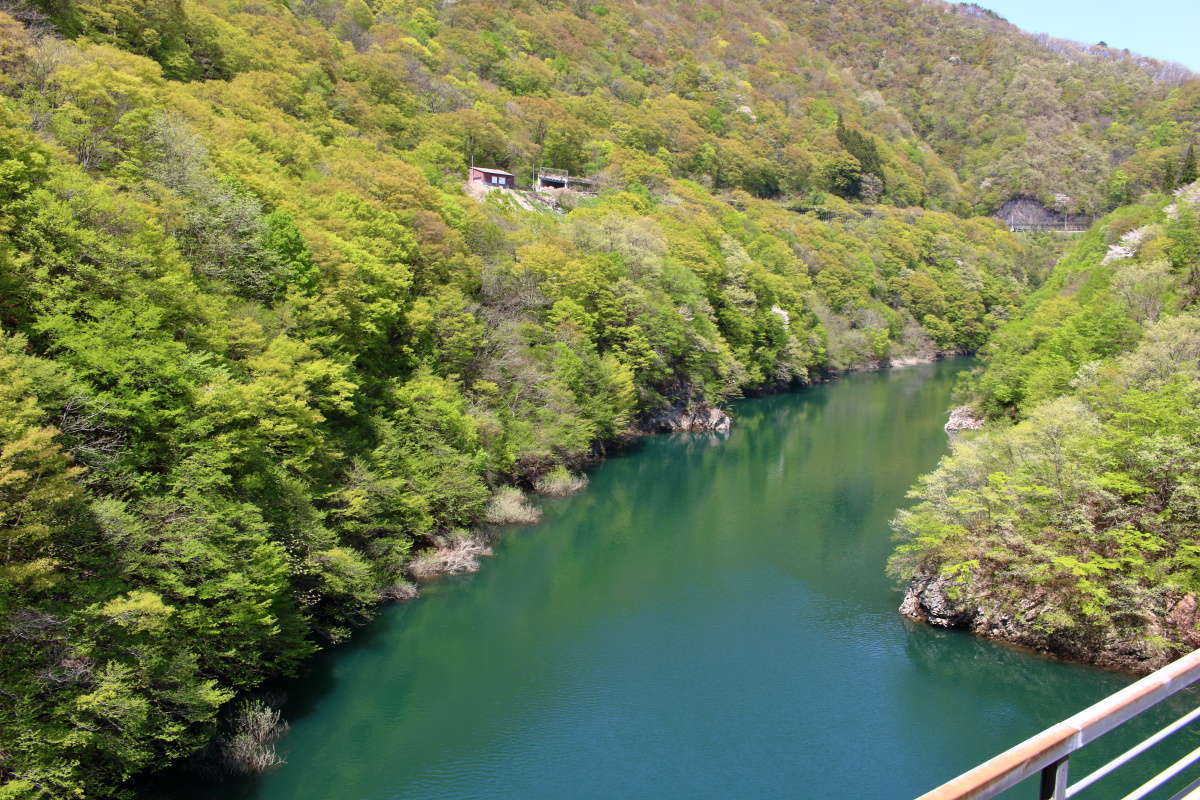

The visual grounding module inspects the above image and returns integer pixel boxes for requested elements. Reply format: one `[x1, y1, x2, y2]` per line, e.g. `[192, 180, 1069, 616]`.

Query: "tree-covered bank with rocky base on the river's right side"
[892, 185, 1200, 670]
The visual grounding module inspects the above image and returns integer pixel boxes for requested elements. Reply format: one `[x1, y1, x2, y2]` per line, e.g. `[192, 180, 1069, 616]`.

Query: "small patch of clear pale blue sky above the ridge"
[977, 0, 1200, 72]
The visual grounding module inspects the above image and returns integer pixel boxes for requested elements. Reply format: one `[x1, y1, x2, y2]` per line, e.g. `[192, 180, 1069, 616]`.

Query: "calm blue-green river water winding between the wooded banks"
[175, 361, 1195, 800]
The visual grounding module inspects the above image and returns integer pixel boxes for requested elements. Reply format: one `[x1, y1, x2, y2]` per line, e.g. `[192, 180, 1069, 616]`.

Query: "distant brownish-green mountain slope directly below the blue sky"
[778, 0, 1200, 213]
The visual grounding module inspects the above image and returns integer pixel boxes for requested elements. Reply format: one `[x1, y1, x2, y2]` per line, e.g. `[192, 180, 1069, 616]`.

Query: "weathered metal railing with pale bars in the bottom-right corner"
[918, 650, 1200, 800]
